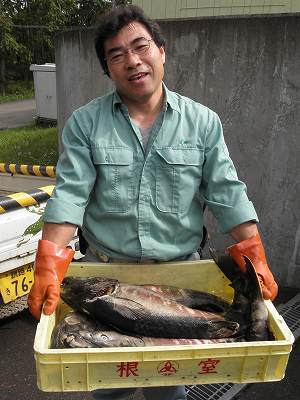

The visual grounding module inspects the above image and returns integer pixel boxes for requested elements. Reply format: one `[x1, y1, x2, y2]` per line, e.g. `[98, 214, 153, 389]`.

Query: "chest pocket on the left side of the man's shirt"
[92, 147, 133, 213]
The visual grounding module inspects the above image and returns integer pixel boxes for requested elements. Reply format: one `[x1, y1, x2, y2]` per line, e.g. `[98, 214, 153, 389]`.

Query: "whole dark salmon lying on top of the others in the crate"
[61, 277, 239, 339]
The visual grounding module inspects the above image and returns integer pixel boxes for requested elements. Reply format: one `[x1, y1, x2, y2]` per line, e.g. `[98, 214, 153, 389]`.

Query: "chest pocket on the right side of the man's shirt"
[156, 148, 204, 213]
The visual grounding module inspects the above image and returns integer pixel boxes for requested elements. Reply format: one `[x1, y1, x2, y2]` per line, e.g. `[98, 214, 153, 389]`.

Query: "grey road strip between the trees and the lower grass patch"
[0, 99, 36, 130]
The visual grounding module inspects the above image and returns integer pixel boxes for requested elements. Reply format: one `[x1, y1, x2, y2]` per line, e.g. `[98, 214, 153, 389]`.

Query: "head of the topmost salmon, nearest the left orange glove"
[60, 276, 118, 310]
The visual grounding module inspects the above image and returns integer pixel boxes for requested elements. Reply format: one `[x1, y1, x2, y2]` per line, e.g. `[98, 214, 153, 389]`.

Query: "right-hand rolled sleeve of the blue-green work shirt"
[200, 110, 258, 233]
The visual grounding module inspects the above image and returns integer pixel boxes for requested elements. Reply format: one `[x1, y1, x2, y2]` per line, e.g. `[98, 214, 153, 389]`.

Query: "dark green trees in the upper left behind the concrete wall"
[0, 0, 130, 90]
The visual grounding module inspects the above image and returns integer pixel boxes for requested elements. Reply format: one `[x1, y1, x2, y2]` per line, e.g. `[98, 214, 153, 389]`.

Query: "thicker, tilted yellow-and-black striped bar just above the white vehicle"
[0, 185, 54, 214]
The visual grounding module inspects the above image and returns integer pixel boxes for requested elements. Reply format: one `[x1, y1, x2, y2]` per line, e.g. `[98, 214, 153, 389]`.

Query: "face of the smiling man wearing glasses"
[104, 22, 165, 103]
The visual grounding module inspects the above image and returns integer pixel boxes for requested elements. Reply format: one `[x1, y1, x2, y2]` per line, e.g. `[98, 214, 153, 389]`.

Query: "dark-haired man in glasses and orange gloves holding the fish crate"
[29, 6, 277, 400]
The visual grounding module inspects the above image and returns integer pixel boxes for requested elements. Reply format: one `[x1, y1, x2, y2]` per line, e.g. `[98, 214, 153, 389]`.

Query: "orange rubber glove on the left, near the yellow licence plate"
[28, 240, 75, 320]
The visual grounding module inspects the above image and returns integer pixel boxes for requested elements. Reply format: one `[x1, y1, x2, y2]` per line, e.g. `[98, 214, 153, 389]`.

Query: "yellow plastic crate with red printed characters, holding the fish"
[34, 260, 294, 392]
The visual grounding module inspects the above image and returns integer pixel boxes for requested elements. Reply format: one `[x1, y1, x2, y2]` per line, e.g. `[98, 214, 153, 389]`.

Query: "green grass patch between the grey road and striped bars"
[0, 125, 58, 166]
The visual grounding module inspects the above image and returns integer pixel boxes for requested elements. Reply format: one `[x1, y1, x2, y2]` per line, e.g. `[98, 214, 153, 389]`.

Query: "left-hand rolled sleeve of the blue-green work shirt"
[43, 112, 96, 226]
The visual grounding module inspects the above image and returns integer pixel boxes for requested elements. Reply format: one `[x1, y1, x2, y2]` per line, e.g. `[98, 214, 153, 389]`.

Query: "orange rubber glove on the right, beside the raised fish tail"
[227, 233, 278, 300]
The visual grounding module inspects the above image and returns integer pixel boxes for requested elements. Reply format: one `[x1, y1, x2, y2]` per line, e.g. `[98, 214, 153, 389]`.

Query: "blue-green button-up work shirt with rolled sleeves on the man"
[43, 86, 257, 261]
